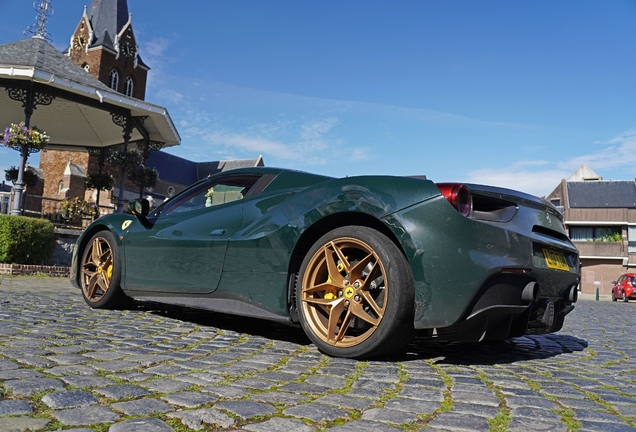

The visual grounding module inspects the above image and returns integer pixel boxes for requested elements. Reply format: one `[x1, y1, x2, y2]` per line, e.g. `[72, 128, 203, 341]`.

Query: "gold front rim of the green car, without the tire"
[82, 237, 113, 302]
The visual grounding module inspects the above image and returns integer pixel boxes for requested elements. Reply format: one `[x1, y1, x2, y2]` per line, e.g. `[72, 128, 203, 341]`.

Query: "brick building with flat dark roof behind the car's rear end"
[547, 165, 636, 295]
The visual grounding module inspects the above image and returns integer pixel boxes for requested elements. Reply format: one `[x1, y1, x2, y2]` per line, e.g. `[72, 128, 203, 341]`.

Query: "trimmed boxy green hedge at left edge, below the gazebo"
[0, 215, 55, 264]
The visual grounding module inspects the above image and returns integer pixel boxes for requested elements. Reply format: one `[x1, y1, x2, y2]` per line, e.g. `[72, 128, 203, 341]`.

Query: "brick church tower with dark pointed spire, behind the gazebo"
[40, 0, 150, 209]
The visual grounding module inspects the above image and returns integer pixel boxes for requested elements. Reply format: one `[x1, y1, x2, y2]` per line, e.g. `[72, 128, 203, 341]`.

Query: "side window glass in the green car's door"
[161, 175, 259, 215]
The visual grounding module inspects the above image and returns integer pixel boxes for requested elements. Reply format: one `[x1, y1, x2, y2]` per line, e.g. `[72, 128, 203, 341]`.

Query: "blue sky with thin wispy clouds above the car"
[0, 0, 636, 195]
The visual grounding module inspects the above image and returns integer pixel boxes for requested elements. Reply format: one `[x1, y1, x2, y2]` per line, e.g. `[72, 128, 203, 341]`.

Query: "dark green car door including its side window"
[123, 176, 258, 294]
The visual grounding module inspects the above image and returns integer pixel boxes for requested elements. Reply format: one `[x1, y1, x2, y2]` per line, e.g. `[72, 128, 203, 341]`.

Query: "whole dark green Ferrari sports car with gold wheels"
[71, 167, 580, 359]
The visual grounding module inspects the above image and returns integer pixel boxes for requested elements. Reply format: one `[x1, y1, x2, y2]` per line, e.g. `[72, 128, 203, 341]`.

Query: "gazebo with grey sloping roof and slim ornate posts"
[0, 36, 181, 215]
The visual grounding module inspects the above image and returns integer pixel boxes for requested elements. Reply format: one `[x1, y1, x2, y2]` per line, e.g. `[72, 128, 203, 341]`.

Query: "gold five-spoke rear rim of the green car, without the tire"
[301, 237, 389, 348]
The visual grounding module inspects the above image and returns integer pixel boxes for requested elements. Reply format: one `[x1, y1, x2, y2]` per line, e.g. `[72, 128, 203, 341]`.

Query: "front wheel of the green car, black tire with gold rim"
[80, 230, 132, 309]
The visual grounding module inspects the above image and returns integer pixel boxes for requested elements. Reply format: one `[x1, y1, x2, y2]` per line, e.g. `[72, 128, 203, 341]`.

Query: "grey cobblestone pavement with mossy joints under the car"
[0, 276, 636, 432]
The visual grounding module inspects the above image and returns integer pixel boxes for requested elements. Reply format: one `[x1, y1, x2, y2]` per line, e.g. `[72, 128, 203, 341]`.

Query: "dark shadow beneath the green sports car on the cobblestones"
[128, 300, 588, 365]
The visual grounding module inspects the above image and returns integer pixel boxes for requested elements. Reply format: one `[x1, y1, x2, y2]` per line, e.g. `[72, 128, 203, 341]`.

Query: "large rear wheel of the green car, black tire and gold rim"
[296, 226, 415, 359]
